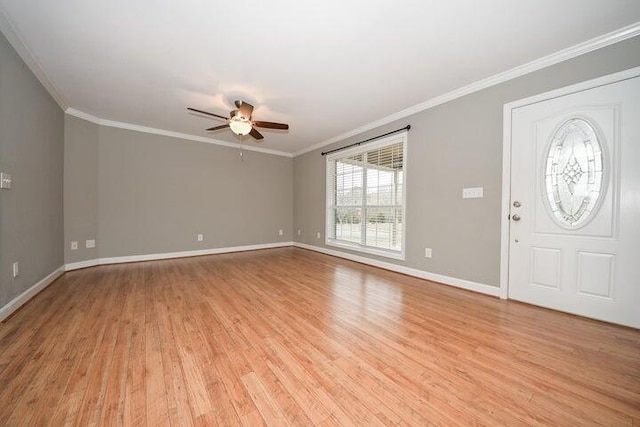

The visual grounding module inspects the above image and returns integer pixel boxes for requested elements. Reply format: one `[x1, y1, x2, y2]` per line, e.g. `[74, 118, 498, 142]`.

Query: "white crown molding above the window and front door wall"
[293, 22, 640, 157]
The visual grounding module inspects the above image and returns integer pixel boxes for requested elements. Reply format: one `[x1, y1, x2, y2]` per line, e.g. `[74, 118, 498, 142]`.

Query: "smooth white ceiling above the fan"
[0, 0, 640, 153]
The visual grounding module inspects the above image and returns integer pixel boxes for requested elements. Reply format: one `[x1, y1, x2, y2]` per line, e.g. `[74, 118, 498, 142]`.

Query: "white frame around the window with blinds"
[325, 131, 408, 261]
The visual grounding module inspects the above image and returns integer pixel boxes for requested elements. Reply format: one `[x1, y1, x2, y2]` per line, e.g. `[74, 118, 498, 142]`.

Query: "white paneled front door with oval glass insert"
[508, 73, 640, 328]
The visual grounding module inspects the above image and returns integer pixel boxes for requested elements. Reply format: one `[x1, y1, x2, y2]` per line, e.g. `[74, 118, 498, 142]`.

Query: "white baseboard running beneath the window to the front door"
[293, 242, 500, 297]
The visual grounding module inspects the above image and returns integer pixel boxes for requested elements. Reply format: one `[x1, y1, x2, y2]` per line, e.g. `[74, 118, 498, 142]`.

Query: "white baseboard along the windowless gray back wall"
[65, 242, 293, 271]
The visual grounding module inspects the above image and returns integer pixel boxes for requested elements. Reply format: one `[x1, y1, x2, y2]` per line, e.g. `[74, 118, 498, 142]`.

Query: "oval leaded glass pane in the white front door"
[544, 118, 604, 229]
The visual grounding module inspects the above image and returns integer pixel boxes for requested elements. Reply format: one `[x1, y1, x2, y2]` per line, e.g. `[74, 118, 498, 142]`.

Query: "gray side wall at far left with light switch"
[0, 34, 64, 307]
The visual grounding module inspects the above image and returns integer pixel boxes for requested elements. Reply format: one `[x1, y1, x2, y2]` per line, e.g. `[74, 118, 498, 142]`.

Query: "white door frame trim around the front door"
[500, 67, 640, 299]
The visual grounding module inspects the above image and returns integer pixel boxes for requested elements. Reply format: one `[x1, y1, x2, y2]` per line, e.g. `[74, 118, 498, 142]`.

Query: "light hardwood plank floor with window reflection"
[0, 248, 640, 426]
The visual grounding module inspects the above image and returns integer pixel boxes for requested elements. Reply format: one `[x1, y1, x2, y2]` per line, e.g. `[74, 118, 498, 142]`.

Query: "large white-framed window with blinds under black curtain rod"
[326, 132, 407, 259]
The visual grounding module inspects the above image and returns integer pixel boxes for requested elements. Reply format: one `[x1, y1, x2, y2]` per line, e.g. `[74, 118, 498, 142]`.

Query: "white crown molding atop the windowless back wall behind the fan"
[65, 108, 293, 158]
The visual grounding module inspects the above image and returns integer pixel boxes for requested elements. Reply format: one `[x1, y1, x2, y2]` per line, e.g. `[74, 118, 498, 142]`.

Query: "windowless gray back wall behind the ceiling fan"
[65, 117, 293, 262]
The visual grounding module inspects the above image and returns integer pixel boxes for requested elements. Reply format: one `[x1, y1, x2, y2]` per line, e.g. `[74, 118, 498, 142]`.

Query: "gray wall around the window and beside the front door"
[293, 37, 640, 286]
